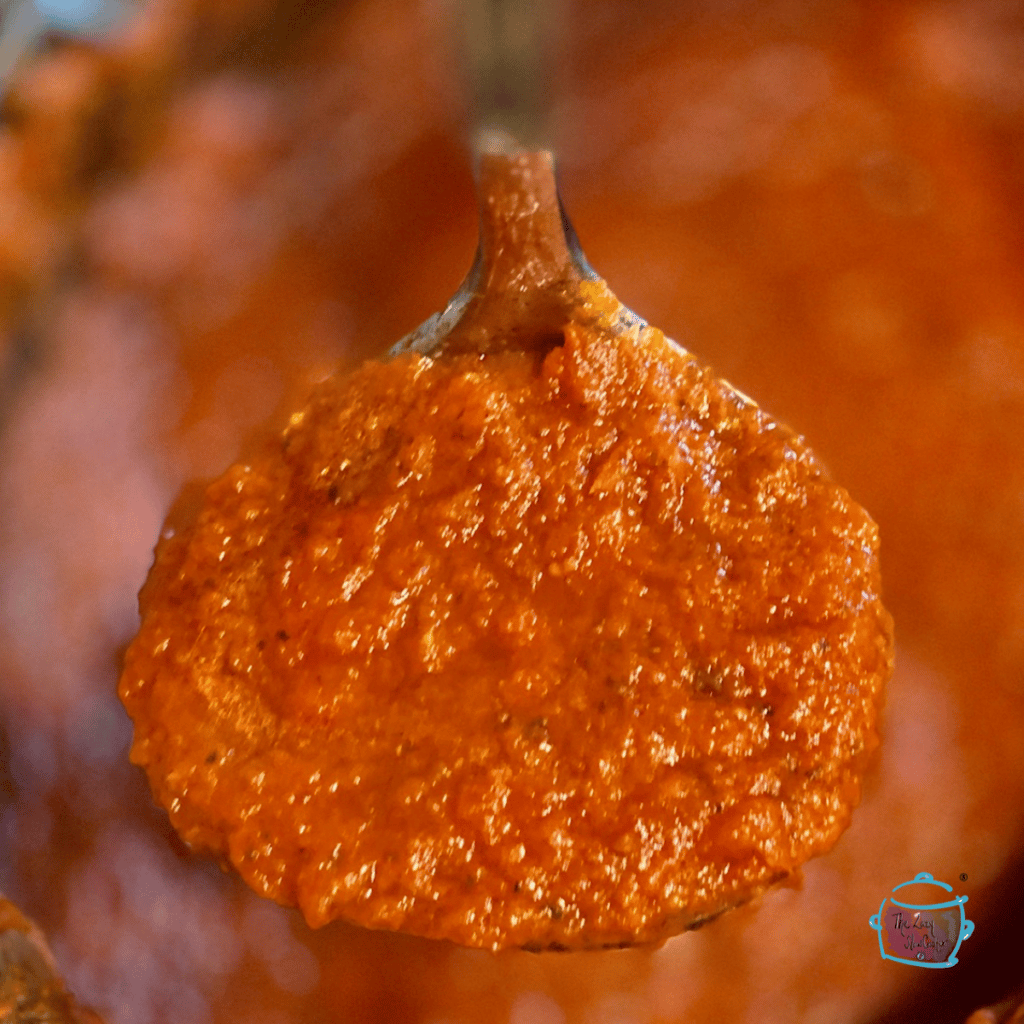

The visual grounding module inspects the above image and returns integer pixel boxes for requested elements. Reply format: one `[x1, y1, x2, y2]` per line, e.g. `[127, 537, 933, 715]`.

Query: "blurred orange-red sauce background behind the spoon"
[0, 0, 1024, 1024]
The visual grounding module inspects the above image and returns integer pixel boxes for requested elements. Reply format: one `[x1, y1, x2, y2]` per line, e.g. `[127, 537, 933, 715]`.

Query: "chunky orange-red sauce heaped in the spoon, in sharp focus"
[121, 151, 892, 949]
